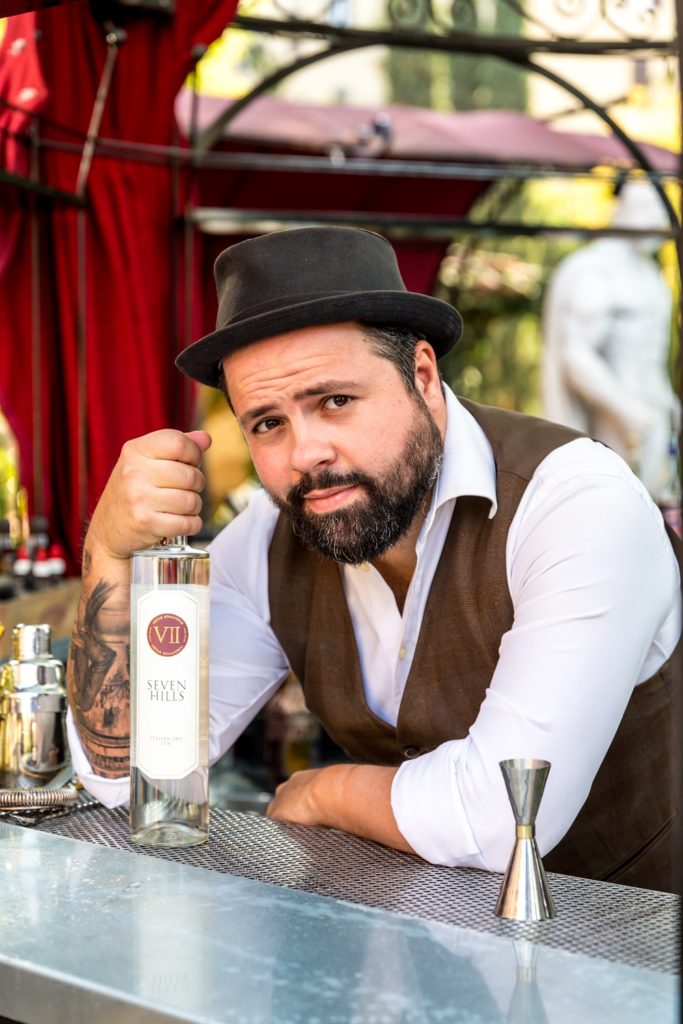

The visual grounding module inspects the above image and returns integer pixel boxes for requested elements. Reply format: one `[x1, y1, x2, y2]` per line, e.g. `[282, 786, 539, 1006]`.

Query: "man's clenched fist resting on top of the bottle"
[88, 430, 211, 558]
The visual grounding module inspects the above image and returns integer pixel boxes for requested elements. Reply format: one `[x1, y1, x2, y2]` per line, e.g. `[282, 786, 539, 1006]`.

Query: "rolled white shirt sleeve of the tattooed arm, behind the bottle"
[68, 493, 289, 807]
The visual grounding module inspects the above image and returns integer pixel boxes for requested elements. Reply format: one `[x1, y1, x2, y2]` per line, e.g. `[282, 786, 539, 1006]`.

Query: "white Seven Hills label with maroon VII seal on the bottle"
[135, 590, 200, 778]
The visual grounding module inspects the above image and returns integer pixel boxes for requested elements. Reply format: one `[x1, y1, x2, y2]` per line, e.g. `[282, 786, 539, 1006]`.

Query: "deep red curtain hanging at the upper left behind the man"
[0, 0, 237, 568]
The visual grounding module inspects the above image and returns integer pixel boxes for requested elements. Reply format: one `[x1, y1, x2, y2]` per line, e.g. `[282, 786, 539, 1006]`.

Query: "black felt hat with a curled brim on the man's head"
[175, 227, 463, 387]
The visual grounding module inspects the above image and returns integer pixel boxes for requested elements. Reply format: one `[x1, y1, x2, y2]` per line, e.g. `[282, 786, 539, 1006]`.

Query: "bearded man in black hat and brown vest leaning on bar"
[70, 227, 680, 889]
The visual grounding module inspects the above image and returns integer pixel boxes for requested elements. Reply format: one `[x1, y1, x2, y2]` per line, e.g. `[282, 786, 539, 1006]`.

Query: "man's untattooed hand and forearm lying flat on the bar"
[266, 765, 415, 853]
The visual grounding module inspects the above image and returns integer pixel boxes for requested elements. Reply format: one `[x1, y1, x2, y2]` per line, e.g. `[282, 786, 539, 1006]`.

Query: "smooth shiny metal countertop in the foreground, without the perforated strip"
[0, 822, 678, 1024]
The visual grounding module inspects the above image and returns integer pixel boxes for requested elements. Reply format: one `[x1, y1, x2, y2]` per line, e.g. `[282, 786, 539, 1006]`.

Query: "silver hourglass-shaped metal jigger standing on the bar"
[496, 758, 555, 921]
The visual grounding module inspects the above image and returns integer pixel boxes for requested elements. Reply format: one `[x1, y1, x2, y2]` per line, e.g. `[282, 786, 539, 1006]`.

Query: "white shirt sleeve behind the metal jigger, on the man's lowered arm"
[391, 440, 680, 871]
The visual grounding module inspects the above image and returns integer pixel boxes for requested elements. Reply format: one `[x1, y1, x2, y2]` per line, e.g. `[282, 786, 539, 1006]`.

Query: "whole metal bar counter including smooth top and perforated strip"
[0, 806, 679, 1024]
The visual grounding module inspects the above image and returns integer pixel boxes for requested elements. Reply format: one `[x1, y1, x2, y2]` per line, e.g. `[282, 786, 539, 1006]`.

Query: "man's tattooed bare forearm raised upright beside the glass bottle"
[67, 542, 130, 778]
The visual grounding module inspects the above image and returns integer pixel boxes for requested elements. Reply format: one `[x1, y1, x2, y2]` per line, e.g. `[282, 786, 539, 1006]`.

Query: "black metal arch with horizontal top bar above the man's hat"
[197, 17, 679, 229]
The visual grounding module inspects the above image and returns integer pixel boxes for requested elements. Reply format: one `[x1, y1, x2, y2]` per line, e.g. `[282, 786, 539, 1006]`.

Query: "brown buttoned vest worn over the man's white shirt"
[269, 399, 682, 891]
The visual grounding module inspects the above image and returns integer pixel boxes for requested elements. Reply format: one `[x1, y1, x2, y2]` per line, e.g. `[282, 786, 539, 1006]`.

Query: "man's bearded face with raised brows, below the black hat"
[223, 324, 442, 563]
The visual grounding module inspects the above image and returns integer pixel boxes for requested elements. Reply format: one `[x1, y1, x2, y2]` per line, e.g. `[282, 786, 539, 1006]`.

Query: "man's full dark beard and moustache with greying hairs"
[269, 397, 443, 565]
